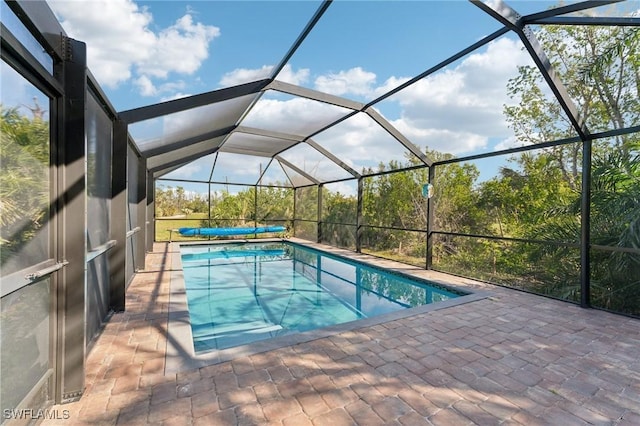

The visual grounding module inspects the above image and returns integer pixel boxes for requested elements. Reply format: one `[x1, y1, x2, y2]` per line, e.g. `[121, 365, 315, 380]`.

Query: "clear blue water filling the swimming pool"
[181, 242, 463, 353]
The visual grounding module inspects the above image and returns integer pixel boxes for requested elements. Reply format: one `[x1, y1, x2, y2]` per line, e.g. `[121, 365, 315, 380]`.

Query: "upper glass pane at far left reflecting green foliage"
[0, 62, 51, 276]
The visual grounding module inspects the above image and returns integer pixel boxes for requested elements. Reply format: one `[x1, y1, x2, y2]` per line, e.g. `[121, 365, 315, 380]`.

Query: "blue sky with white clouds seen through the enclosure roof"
[7, 0, 632, 193]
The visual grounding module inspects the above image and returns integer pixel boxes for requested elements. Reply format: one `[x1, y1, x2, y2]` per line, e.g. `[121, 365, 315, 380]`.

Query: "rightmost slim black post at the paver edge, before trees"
[580, 140, 592, 308]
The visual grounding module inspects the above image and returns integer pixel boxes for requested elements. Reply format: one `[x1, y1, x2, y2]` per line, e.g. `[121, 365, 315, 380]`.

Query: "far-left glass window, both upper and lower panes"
[0, 60, 51, 412]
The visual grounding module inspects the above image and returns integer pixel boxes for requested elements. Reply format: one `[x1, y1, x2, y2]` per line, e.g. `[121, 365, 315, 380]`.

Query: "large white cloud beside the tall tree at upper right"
[382, 38, 531, 154]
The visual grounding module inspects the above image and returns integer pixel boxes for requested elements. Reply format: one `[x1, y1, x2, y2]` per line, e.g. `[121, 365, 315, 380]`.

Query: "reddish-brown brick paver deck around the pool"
[42, 243, 640, 426]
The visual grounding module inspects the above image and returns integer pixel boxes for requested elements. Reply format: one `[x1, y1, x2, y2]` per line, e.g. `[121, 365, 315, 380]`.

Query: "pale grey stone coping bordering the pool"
[165, 238, 493, 374]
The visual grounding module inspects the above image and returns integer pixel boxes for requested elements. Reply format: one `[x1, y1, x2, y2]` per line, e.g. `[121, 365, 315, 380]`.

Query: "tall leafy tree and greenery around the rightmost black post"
[500, 19, 640, 314]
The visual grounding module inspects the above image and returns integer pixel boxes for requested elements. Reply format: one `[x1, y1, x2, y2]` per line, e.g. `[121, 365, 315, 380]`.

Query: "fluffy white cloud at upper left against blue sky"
[48, 0, 220, 96]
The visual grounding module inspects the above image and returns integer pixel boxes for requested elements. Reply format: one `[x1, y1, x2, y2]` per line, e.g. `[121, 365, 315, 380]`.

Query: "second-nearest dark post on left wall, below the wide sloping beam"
[108, 120, 128, 312]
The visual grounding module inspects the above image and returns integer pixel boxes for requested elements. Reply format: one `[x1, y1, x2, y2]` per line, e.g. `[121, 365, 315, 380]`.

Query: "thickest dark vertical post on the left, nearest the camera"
[54, 36, 87, 403]
